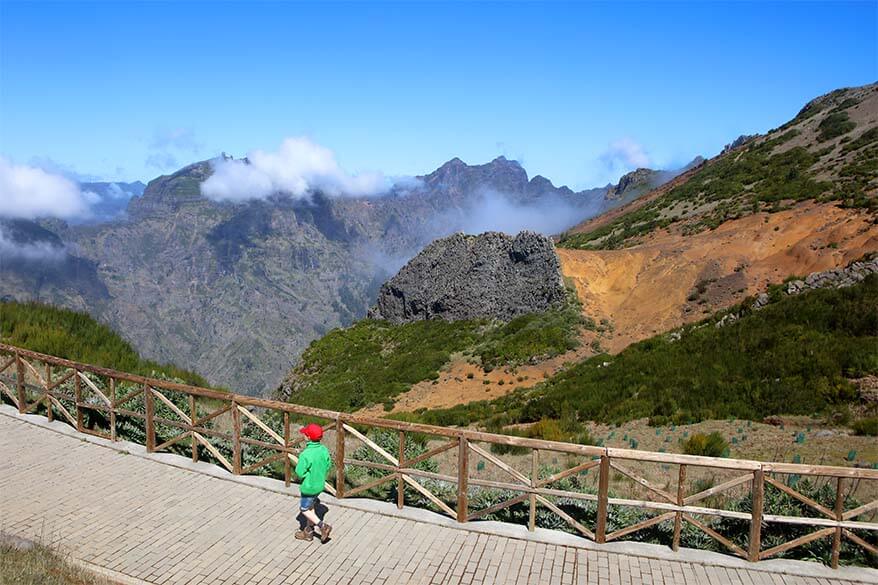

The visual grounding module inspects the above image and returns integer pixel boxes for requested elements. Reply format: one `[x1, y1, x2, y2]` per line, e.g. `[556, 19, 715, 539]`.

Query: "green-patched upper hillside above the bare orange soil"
[559, 85, 878, 249]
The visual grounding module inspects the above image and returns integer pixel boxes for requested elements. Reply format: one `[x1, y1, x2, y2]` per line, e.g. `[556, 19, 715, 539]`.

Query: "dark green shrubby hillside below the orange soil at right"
[417, 275, 878, 432]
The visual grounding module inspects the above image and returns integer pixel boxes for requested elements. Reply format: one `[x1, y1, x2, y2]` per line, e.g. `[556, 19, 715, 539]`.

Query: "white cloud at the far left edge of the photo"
[0, 156, 100, 219]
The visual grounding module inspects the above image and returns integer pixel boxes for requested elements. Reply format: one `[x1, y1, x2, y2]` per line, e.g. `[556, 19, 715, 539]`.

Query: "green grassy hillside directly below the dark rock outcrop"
[279, 294, 583, 411]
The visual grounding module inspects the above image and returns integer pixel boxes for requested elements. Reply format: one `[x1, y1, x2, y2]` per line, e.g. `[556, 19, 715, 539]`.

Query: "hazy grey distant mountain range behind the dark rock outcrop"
[0, 157, 699, 394]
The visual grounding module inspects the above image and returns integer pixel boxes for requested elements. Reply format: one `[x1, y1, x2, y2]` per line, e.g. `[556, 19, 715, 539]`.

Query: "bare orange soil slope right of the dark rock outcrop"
[558, 198, 878, 352]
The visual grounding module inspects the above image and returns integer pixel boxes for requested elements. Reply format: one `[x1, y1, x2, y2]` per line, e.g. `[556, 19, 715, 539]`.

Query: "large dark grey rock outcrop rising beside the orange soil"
[369, 232, 565, 323]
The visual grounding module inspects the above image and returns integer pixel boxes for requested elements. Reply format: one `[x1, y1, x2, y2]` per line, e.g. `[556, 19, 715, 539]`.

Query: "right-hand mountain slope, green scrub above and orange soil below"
[558, 85, 878, 351]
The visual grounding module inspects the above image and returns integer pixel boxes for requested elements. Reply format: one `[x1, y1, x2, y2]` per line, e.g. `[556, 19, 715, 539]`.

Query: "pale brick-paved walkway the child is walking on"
[0, 407, 873, 585]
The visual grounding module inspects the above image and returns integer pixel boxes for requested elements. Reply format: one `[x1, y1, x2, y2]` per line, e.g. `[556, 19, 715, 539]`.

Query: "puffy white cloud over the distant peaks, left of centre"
[201, 137, 389, 201]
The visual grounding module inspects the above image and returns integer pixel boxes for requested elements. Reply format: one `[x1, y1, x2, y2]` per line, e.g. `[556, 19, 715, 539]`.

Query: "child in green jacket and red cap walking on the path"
[296, 423, 332, 542]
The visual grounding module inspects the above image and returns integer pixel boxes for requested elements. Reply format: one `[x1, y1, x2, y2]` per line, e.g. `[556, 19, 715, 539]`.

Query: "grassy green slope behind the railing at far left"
[0, 302, 208, 386]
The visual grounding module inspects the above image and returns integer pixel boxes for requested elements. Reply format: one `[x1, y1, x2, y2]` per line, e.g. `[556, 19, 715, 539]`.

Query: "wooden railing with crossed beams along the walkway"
[0, 344, 878, 567]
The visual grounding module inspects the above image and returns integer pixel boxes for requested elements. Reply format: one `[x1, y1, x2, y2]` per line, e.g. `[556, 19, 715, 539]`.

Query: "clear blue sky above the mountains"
[0, 0, 878, 188]
